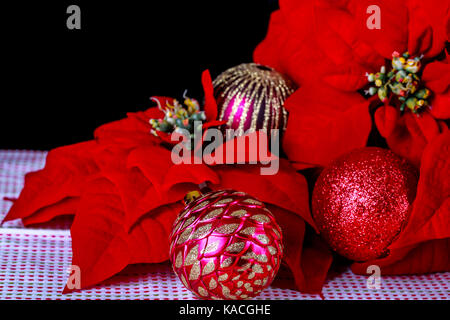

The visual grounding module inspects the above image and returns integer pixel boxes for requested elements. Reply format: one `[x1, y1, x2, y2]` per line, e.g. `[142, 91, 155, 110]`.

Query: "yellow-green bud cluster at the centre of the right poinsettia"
[365, 51, 430, 113]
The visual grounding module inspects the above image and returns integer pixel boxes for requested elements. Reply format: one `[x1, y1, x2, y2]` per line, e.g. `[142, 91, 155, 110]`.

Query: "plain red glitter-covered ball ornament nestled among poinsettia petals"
[312, 147, 418, 261]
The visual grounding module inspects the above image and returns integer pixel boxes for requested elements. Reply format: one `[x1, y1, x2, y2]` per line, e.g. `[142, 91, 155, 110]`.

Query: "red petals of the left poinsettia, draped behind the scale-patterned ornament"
[0, 69, 331, 292]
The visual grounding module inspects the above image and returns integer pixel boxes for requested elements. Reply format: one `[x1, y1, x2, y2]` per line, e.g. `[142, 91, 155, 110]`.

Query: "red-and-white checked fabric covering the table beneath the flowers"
[0, 150, 450, 300]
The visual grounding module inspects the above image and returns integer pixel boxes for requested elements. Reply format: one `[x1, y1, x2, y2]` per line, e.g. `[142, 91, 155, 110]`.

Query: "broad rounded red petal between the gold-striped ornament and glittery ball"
[283, 87, 372, 166]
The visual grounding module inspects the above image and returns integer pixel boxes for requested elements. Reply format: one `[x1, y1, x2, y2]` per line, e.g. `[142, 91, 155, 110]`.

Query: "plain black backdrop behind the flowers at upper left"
[0, 0, 277, 150]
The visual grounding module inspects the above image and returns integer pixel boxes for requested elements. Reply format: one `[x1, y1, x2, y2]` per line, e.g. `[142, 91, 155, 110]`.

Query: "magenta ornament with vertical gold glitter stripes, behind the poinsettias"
[213, 63, 295, 135]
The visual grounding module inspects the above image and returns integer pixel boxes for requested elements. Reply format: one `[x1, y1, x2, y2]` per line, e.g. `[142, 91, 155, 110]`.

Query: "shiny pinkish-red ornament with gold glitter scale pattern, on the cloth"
[170, 190, 283, 299]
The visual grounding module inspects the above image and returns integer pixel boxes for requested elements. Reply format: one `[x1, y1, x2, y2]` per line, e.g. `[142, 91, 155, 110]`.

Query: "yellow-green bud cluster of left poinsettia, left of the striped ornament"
[149, 96, 206, 136]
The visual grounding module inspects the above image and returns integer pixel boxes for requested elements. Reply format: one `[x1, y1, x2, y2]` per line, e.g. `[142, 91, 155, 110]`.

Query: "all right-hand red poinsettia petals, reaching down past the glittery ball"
[254, 0, 450, 274]
